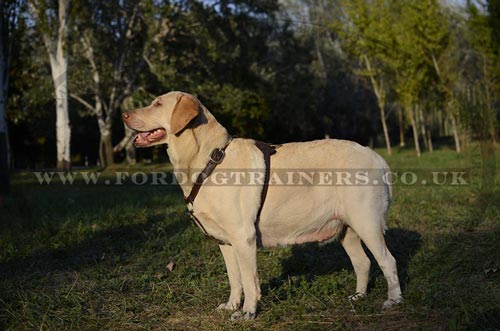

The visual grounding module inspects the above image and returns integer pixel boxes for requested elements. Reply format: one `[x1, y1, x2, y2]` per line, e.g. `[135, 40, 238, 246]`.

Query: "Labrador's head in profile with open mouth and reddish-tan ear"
[122, 92, 200, 147]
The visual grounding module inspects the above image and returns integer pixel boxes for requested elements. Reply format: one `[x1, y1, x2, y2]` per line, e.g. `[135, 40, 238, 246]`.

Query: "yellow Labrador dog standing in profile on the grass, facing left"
[123, 92, 402, 319]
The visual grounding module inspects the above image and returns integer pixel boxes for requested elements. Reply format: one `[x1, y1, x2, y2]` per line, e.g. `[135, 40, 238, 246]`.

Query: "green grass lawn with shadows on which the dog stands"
[0, 149, 500, 331]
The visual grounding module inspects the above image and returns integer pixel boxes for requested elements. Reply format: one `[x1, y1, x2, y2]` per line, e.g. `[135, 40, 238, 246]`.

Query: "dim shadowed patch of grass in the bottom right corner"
[420, 189, 500, 330]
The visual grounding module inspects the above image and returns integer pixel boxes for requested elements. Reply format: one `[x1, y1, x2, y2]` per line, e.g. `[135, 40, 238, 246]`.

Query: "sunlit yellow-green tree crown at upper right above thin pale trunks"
[335, 0, 449, 105]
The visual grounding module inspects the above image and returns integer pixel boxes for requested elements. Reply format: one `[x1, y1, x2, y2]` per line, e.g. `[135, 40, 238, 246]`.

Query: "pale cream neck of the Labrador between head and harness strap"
[167, 106, 230, 196]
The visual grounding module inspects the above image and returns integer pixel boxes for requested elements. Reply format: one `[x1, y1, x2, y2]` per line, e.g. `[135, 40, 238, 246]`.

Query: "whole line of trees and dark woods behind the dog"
[0, 0, 500, 169]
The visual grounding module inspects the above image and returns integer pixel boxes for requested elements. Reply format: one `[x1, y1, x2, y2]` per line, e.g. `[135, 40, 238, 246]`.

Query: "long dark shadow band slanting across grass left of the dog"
[0, 214, 190, 280]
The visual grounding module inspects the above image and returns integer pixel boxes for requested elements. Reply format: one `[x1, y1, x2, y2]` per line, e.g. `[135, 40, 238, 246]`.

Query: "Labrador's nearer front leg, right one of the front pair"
[231, 233, 260, 320]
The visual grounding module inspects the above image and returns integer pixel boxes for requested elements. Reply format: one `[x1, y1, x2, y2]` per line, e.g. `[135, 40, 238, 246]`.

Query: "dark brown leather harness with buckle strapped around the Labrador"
[184, 138, 277, 245]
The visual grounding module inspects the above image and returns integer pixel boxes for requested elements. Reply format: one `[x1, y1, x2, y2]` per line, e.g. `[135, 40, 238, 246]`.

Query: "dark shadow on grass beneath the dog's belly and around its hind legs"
[262, 228, 421, 293]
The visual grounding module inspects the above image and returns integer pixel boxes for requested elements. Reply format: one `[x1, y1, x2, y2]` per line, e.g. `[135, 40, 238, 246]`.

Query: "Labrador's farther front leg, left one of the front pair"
[217, 245, 243, 310]
